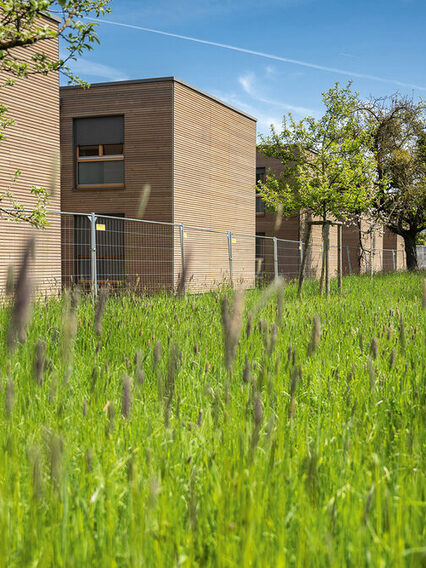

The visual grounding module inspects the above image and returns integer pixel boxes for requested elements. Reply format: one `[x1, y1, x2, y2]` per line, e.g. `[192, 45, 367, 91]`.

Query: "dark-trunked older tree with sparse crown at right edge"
[359, 94, 426, 270]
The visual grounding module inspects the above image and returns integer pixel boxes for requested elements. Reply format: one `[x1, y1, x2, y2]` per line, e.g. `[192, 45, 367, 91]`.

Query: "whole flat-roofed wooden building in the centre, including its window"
[61, 77, 256, 290]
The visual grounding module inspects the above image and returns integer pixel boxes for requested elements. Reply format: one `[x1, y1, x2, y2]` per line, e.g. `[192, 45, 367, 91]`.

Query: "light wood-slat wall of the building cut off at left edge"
[0, 17, 61, 292]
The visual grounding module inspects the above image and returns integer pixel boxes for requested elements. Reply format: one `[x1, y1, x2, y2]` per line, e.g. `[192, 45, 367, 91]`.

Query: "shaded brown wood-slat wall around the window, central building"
[61, 81, 173, 289]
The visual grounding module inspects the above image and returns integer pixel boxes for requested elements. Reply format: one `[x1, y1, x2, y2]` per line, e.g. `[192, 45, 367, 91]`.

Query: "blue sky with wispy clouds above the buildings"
[63, 0, 426, 133]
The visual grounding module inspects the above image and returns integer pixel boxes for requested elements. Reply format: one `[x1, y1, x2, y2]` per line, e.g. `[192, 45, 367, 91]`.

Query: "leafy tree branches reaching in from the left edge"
[0, 0, 110, 226]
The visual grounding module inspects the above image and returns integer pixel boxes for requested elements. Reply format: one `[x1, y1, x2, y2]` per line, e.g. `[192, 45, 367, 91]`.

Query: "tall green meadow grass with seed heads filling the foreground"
[0, 274, 426, 568]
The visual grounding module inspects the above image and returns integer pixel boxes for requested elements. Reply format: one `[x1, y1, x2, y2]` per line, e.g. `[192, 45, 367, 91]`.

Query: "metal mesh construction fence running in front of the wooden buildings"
[0, 212, 412, 295]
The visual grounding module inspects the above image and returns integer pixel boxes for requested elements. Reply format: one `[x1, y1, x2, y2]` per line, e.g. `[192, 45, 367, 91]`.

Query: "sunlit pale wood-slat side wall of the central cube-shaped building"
[174, 82, 256, 290]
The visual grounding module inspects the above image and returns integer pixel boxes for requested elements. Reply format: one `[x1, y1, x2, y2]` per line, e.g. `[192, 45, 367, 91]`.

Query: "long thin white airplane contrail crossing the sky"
[83, 18, 426, 91]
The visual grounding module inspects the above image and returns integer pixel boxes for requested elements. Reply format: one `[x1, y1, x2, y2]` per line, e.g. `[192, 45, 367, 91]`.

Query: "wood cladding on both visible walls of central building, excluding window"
[61, 77, 256, 289]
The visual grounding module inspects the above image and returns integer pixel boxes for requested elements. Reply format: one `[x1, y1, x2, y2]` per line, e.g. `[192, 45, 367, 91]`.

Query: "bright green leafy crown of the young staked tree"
[260, 83, 375, 219]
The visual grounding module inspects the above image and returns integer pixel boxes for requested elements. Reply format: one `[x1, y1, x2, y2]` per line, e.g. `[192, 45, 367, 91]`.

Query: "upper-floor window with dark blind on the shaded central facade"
[74, 116, 124, 189]
